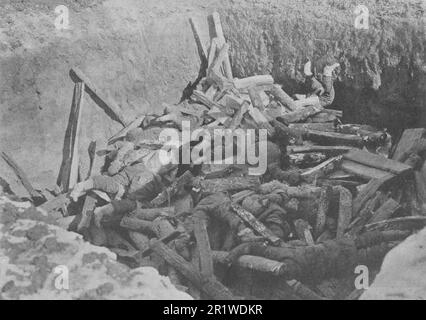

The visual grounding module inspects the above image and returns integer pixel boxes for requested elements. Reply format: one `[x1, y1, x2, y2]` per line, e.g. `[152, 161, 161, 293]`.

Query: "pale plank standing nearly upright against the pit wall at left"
[66, 82, 85, 191]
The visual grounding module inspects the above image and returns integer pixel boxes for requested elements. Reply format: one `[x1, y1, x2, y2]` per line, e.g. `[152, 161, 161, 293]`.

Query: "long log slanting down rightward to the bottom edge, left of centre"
[151, 241, 236, 300]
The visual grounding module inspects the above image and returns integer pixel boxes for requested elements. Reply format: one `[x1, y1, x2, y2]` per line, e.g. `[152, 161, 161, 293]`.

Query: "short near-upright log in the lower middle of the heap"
[193, 212, 214, 278]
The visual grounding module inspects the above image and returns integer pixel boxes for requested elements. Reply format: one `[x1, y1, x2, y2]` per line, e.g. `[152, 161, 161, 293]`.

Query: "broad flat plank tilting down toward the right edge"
[343, 149, 412, 174]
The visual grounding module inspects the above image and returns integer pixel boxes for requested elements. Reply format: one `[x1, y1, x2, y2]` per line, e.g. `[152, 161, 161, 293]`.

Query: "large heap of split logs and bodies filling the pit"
[3, 13, 426, 299]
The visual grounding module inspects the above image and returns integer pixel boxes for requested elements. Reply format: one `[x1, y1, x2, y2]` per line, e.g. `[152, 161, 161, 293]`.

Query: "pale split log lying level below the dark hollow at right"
[304, 130, 363, 147]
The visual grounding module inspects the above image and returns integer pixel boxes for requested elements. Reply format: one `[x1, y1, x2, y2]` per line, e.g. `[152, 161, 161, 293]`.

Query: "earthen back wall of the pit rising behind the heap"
[0, 0, 426, 298]
